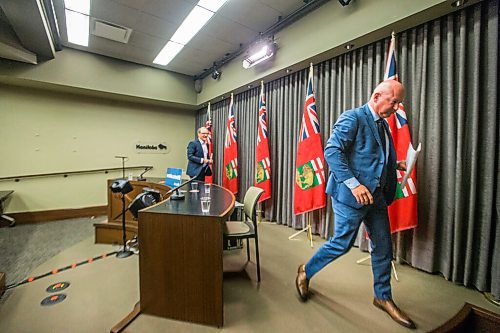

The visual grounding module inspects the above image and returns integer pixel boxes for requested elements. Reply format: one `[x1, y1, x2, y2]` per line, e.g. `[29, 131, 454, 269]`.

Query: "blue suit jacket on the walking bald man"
[325, 104, 397, 208]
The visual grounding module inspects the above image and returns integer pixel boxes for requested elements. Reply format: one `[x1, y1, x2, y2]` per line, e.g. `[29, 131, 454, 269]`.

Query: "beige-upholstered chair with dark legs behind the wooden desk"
[224, 186, 264, 282]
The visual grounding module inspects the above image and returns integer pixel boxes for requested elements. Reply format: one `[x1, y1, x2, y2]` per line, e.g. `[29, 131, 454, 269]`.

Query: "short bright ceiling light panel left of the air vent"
[64, 0, 90, 46]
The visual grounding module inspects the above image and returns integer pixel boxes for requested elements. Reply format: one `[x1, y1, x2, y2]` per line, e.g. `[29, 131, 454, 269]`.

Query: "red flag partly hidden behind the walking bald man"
[384, 33, 418, 233]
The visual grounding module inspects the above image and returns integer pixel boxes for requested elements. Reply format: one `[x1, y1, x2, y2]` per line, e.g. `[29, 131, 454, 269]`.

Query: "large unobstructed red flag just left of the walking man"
[294, 64, 326, 215]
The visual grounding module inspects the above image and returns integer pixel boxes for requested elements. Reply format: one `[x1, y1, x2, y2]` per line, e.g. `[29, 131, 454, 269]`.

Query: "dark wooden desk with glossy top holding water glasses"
[111, 182, 235, 332]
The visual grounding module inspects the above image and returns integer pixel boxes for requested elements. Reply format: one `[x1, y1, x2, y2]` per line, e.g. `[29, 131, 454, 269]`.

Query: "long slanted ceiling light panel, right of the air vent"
[153, 0, 227, 66]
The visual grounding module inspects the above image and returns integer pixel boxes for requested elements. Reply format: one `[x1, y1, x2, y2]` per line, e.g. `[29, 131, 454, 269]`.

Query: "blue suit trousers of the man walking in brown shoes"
[305, 188, 392, 300]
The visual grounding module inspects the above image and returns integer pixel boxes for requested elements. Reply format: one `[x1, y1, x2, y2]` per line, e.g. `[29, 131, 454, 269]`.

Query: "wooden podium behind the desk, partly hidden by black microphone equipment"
[94, 178, 170, 244]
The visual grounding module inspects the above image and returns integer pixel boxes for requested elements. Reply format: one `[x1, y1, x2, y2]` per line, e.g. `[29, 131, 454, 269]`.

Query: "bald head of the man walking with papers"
[368, 80, 405, 118]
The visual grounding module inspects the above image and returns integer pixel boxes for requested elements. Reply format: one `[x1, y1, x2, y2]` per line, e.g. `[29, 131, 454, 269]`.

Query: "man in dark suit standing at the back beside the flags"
[186, 127, 212, 181]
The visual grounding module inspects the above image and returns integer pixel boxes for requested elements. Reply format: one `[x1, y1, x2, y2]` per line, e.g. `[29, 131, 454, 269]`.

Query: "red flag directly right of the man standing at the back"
[222, 94, 238, 194]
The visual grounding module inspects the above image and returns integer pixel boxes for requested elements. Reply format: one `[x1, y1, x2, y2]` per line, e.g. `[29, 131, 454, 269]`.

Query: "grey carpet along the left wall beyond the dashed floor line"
[0, 217, 100, 304]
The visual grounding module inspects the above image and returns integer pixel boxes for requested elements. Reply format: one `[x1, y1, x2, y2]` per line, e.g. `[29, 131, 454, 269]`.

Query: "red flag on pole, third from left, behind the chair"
[255, 82, 271, 202]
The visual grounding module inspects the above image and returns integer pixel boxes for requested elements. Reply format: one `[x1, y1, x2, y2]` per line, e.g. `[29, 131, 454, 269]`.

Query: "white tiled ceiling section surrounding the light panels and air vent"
[30, 0, 320, 75]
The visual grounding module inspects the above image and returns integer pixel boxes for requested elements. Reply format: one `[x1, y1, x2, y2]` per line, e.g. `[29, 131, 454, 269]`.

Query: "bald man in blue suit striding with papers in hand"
[295, 80, 416, 328]
